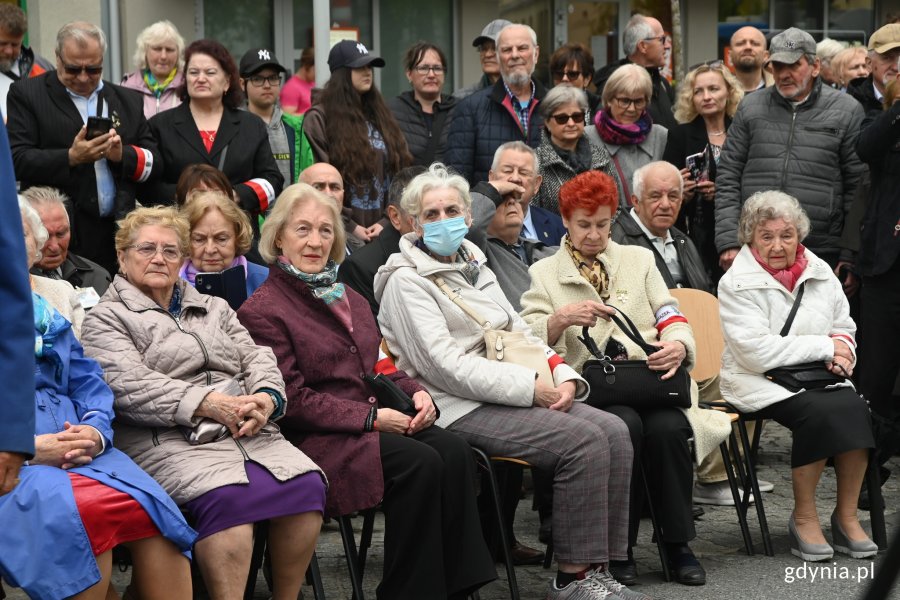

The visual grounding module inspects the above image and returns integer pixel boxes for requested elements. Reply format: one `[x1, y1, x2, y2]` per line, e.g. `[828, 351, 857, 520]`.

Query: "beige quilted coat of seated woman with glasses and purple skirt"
[83, 276, 324, 505]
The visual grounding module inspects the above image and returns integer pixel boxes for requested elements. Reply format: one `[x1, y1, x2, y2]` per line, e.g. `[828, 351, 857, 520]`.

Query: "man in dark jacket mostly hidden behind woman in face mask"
[338, 165, 425, 319]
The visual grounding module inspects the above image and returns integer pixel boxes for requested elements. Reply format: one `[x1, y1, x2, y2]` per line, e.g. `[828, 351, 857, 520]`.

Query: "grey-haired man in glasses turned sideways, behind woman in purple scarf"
[594, 15, 678, 129]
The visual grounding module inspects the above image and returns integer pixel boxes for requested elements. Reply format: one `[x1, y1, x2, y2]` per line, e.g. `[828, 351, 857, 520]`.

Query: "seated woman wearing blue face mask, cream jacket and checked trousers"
[375, 164, 647, 600]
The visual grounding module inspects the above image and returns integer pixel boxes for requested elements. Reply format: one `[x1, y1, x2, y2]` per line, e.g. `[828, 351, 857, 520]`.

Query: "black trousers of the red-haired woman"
[600, 400, 697, 549]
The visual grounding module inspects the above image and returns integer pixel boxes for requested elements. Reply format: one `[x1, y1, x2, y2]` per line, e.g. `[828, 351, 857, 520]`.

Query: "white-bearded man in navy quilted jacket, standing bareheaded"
[444, 23, 547, 185]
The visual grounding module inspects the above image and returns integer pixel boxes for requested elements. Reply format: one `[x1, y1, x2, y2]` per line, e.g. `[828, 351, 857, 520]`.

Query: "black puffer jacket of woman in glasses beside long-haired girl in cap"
[388, 91, 457, 167]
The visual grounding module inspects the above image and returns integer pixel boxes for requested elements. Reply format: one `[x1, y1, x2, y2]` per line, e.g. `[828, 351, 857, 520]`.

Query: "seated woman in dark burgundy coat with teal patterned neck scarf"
[238, 184, 496, 600]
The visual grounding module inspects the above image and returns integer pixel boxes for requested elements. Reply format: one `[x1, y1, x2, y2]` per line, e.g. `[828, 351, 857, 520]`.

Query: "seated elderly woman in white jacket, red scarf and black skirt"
[719, 191, 878, 561]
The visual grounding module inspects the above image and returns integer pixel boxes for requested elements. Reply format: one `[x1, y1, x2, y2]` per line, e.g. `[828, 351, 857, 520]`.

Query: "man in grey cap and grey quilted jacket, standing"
[715, 27, 863, 276]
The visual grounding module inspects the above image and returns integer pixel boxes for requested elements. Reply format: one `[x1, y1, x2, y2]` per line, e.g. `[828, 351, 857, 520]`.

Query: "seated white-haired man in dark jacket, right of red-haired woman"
[612, 161, 713, 293]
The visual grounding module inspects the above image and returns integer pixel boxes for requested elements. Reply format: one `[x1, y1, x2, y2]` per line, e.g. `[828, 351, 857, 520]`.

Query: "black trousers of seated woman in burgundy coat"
[376, 426, 497, 600]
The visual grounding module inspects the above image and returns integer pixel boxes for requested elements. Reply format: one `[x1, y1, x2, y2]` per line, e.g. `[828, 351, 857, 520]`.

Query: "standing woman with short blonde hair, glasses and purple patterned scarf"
[587, 64, 668, 210]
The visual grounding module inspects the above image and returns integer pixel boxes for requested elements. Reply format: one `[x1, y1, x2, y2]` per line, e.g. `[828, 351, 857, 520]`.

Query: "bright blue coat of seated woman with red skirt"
[0, 316, 197, 598]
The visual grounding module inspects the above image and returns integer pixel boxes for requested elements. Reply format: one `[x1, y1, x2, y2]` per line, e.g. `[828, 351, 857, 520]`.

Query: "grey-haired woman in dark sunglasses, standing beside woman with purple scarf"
[534, 84, 615, 215]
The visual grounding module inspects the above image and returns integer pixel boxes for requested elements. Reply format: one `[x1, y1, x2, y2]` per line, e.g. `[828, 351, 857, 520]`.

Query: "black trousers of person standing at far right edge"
[858, 260, 900, 464]
